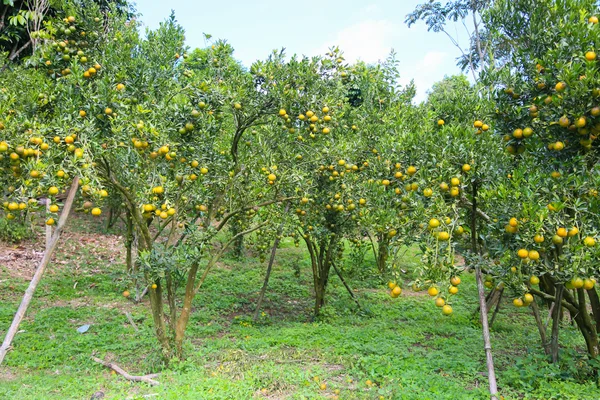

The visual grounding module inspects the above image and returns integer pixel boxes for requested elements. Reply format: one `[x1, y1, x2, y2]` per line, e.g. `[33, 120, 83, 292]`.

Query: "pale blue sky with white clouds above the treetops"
[136, 0, 468, 102]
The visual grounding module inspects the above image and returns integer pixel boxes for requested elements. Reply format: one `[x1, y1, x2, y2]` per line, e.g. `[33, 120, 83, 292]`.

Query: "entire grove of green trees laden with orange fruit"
[0, 0, 600, 398]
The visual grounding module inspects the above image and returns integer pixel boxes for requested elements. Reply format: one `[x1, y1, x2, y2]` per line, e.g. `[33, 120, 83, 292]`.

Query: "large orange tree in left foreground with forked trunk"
[0, 3, 304, 356]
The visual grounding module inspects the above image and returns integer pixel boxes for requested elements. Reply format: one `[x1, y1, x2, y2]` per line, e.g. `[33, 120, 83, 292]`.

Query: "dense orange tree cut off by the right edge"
[480, 1, 600, 360]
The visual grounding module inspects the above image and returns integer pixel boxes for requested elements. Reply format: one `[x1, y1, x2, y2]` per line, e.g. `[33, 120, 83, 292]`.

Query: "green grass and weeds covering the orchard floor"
[0, 218, 600, 400]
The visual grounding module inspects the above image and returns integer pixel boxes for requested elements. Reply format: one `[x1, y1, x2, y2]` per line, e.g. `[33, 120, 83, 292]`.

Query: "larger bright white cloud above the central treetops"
[316, 19, 400, 63]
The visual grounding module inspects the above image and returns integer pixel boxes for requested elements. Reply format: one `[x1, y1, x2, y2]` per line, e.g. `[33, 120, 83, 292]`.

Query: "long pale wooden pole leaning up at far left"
[0, 177, 79, 364]
